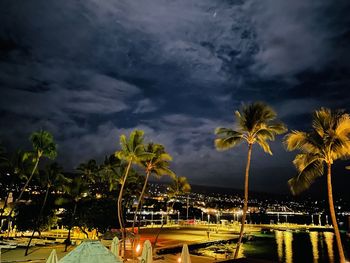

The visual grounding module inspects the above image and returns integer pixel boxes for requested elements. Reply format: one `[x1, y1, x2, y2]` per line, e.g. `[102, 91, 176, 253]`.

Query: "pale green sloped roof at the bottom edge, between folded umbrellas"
[58, 240, 122, 263]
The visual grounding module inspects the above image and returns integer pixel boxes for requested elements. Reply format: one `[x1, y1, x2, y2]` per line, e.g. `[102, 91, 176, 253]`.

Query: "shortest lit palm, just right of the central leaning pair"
[153, 176, 191, 253]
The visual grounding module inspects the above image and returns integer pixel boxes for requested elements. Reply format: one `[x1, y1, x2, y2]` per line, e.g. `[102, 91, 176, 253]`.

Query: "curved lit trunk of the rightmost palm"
[327, 163, 345, 263]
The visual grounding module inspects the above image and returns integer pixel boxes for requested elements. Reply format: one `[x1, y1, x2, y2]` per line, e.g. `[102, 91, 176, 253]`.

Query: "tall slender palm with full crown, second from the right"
[215, 102, 287, 258]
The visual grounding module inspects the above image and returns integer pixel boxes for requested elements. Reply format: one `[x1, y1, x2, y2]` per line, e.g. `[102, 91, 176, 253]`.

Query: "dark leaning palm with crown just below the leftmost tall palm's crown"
[24, 163, 71, 256]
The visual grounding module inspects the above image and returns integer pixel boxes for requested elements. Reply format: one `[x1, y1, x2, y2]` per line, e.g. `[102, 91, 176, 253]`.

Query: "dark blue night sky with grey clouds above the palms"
[0, 0, 350, 196]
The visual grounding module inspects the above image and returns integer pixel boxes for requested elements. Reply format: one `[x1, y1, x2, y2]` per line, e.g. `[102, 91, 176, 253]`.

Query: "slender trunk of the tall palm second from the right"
[234, 143, 253, 259]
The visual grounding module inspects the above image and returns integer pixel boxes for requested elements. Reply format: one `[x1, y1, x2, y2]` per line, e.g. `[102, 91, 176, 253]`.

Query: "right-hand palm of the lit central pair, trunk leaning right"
[132, 143, 175, 233]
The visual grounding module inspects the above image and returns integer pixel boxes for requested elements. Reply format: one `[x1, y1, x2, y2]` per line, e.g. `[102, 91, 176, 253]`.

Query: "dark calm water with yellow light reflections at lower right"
[243, 230, 350, 263]
